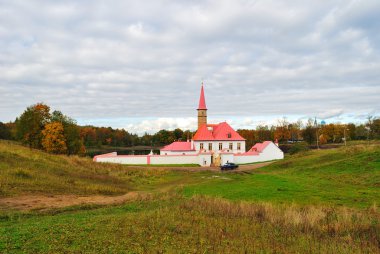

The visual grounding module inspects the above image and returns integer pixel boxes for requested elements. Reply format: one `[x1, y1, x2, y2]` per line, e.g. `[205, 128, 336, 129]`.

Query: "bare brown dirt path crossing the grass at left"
[0, 192, 149, 211]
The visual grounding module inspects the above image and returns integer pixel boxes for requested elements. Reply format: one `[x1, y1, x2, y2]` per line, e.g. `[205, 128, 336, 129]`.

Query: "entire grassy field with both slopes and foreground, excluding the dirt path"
[0, 141, 380, 253]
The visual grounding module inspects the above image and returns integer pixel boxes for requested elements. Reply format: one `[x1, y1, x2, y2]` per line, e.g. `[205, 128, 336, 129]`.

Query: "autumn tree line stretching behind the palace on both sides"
[0, 103, 380, 155]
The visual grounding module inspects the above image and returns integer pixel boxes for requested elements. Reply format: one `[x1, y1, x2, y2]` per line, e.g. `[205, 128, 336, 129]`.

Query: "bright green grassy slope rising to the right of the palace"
[184, 146, 380, 208]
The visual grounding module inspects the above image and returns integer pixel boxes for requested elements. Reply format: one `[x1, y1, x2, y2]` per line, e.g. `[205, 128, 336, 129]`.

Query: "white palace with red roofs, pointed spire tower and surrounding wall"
[94, 83, 284, 167]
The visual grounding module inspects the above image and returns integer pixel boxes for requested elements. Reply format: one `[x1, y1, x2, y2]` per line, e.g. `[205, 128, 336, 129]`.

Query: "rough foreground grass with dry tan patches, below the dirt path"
[0, 194, 380, 253]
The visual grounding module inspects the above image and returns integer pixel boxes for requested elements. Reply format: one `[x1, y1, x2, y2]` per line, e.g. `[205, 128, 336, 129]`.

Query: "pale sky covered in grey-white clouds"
[0, 0, 380, 134]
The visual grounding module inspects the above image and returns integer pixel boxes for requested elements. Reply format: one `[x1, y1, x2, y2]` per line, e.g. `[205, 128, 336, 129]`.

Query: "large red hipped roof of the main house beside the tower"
[193, 122, 245, 141]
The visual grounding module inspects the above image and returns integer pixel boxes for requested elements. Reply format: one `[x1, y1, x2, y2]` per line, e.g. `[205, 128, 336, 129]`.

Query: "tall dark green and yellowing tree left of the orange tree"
[16, 103, 50, 148]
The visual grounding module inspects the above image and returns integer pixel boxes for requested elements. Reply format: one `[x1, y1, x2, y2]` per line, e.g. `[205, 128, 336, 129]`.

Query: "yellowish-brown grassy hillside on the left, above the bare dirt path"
[0, 140, 174, 197]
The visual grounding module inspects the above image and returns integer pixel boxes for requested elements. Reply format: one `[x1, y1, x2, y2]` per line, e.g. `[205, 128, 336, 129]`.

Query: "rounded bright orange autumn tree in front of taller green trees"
[42, 122, 67, 154]
